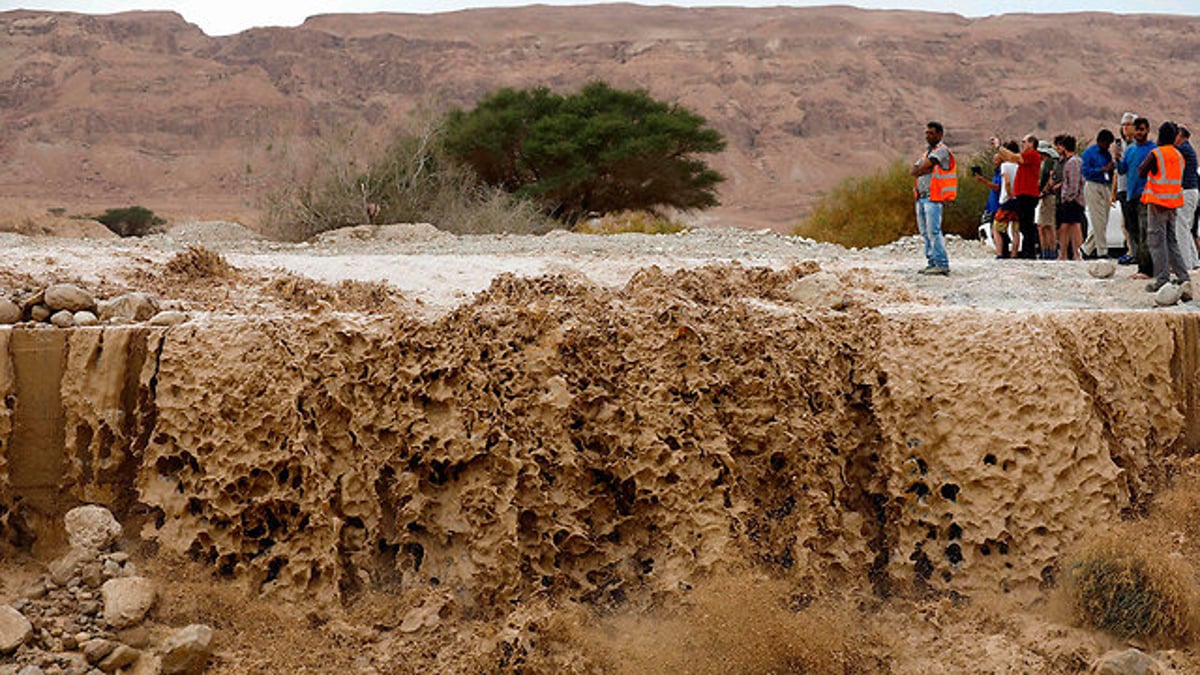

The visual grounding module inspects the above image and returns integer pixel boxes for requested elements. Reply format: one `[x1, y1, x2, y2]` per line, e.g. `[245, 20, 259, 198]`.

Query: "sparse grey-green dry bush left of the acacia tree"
[263, 123, 553, 240]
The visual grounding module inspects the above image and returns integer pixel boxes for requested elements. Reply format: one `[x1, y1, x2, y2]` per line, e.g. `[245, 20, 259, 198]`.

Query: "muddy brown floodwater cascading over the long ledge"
[0, 267, 1200, 615]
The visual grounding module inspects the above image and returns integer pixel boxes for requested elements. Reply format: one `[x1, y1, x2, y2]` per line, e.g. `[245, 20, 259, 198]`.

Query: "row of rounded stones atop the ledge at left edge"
[0, 283, 187, 328]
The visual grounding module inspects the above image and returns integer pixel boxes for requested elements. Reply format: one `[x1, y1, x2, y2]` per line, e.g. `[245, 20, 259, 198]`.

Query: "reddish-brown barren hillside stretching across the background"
[0, 5, 1200, 228]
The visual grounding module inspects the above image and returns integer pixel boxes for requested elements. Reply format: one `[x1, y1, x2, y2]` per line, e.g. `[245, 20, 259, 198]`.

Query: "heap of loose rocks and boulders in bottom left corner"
[0, 506, 212, 675]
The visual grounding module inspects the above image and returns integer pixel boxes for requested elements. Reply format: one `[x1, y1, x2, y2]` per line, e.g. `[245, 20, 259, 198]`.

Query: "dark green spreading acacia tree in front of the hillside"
[445, 82, 725, 223]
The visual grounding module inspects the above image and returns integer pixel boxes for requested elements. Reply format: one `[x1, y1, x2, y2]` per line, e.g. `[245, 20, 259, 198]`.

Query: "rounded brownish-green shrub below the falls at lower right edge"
[1066, 526, 1200, 644]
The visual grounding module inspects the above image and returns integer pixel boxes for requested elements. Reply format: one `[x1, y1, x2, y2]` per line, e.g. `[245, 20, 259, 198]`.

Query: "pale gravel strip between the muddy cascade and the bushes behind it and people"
[0, 222, 1200, 312]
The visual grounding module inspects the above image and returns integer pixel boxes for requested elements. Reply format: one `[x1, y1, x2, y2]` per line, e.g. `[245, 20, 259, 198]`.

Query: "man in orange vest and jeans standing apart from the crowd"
[910, 121, 959, 276]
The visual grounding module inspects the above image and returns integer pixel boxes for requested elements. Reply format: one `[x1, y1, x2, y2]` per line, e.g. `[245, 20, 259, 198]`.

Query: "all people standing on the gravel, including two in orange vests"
[911, 113, 1200, 294]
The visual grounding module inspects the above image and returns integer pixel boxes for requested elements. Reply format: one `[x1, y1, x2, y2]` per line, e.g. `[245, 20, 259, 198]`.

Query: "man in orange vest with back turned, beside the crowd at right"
[1138, 121, 1192, 295]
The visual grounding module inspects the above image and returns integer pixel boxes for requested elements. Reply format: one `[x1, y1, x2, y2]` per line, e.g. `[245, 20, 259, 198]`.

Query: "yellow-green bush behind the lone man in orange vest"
[794, 145, 991, 247]
